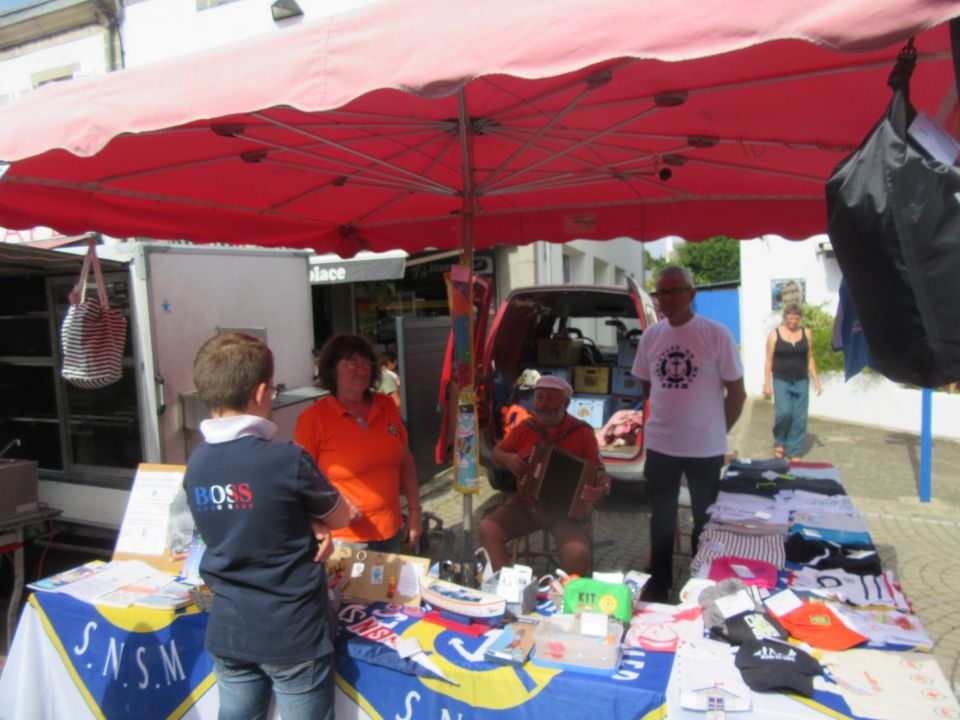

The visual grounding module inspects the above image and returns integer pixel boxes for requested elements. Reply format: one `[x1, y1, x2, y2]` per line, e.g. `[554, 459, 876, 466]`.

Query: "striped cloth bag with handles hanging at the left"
[60, 242, 127, 390]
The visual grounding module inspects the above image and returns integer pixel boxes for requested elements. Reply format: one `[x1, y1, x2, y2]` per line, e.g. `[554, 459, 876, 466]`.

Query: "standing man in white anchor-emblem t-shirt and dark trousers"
[632, 265, 747, 602]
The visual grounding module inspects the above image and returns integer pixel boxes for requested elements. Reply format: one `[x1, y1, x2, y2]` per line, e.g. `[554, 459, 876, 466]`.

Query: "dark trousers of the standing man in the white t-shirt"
[643, 450, 723, 589]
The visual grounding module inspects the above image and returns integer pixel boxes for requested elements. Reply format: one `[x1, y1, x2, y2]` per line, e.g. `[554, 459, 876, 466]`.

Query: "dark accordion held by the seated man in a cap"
[517, 445, 600, 520]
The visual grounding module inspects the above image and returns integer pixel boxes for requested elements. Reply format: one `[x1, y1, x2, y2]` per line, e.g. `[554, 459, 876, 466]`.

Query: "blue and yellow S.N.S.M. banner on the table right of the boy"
[337, 601, 674, 720]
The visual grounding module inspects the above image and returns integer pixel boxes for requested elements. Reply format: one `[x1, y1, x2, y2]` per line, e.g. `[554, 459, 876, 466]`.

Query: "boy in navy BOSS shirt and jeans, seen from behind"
[183, 333, 355, 720]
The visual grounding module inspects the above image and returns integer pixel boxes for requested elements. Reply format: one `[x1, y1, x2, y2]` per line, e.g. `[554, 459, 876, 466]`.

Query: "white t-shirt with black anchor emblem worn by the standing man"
[631, 315, 743, 457]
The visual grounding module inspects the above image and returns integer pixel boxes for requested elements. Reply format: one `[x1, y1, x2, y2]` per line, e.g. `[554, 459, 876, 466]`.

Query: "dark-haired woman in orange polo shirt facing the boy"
[293, 334, 422, 552]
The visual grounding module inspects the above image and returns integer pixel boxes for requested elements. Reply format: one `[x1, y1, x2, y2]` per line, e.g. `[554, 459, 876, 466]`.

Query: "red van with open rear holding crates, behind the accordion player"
[438, 279, 657, 491]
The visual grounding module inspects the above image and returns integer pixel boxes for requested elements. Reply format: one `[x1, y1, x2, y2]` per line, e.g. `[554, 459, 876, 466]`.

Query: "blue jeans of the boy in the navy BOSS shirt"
[213, 654, 334, 720]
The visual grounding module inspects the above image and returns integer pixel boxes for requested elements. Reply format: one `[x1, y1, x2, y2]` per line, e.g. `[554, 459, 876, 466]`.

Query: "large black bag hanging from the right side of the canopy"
[827, 41, 960, 387]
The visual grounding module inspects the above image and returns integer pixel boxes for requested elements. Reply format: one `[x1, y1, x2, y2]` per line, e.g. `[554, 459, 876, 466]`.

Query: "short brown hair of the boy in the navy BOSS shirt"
[193, 332, 273, 412]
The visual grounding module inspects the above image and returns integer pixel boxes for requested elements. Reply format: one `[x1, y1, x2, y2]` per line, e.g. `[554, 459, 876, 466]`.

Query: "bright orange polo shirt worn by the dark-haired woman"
[293, 393, 407, 542]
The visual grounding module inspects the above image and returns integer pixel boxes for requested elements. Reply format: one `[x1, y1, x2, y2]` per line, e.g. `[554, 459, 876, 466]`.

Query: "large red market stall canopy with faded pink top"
[0, 0, 960, 256]
